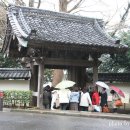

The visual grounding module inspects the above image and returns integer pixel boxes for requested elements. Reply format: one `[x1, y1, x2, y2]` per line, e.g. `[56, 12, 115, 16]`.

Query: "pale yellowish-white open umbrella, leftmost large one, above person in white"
[55, 80, 76, 89]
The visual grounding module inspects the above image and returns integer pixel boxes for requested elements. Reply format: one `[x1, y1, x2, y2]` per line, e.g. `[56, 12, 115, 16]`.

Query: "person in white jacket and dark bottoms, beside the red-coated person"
[79, 87, 92, 111]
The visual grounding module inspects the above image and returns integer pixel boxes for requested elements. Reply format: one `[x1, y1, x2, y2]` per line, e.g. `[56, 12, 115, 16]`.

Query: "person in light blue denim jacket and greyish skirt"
[70, 87, 80, 111]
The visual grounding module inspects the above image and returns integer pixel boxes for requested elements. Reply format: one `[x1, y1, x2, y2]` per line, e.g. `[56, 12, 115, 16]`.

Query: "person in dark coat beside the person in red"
[99, 88, 108, 110]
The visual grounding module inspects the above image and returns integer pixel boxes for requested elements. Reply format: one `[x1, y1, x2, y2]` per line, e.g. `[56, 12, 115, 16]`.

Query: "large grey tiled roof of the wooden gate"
[2, 5, 127, 52]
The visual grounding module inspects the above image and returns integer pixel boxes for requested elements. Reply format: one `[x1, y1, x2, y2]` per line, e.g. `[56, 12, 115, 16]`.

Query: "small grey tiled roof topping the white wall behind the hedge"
[0, 68, 31, 79]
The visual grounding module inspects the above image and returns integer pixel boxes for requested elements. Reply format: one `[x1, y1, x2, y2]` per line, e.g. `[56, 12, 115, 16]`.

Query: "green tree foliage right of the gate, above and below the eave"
[99, 31, 130, 72]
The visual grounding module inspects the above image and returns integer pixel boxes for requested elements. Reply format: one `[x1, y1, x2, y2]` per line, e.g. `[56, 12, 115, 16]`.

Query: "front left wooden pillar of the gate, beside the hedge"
[37, 62, 44, 108]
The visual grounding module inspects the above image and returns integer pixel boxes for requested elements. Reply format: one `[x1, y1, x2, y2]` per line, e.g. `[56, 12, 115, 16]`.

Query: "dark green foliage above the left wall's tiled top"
[0, 53, 21, 68]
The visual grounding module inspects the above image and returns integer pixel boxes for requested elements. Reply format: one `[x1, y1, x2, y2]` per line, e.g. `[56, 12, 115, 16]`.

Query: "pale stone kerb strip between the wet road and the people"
[10, 109, 130, 121]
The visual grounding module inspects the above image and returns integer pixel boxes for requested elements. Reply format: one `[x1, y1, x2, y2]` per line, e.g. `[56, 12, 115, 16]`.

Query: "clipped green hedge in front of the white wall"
[3, 90, 32, 107]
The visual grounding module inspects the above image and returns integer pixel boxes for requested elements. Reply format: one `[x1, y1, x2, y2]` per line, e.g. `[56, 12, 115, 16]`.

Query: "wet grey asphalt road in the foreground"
[0, 111, 130, 130]
